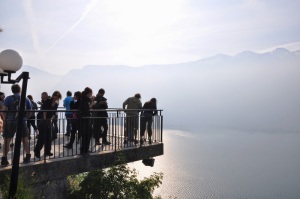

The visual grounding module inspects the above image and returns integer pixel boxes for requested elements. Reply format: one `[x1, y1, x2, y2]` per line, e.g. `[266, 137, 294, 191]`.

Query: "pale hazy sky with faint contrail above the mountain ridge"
[0, 0, 300, 74]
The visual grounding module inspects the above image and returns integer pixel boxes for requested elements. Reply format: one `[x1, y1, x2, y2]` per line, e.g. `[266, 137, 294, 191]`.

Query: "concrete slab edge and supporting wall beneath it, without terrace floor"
[0, 143, 163, 199]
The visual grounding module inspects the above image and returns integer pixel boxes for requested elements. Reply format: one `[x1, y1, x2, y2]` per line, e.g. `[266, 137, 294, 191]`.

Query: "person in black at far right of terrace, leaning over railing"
[140, 98, 157, 144]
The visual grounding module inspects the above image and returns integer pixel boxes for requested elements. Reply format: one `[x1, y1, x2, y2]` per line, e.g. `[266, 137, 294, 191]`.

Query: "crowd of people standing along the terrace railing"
[0, 84, 157, 166]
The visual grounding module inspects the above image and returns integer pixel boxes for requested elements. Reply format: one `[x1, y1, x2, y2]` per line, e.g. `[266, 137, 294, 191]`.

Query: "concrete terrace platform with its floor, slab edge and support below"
[0, 134, 164, 198]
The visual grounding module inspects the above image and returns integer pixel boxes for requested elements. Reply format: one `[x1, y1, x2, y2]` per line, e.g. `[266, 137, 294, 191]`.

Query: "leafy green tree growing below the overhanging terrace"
[69, 164, 163, 199]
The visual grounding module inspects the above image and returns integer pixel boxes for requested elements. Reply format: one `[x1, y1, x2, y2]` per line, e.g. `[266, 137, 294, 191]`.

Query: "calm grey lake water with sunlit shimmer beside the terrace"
[130, 129, 300, 199]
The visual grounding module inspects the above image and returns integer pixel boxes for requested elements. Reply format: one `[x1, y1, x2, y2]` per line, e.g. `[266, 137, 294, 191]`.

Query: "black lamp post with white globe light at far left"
[0, 50, 29, 198]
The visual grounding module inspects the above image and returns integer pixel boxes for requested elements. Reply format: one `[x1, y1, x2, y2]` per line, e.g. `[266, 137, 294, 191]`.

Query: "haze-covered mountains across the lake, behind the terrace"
[1, 48, 300, 132]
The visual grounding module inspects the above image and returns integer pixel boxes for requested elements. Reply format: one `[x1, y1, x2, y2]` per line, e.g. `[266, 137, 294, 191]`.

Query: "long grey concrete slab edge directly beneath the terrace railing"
[0, 143, 163, 182]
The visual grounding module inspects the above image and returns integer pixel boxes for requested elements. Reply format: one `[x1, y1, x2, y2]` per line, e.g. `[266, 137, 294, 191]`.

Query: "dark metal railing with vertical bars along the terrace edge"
[1, 108, 163, 163]
